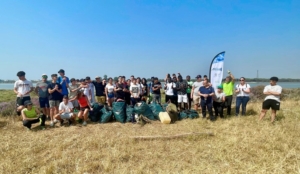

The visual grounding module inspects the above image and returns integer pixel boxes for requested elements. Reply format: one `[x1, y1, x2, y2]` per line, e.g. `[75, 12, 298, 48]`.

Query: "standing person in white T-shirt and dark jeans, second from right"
[235, 77, 250, 116]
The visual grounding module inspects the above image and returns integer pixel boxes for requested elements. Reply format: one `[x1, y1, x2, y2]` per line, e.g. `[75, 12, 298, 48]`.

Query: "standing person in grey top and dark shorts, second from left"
[35, 74, 50, 117]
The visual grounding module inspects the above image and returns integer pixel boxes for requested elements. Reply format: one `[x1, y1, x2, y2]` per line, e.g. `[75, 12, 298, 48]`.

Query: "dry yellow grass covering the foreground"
[0, 101, 300, 173]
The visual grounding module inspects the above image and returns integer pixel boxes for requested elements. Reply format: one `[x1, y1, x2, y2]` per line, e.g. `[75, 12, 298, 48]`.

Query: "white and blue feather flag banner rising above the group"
[209, 51, 225, 89]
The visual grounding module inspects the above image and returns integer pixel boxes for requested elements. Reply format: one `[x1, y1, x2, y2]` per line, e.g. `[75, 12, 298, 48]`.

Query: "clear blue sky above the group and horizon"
[0, 0, 300, 79]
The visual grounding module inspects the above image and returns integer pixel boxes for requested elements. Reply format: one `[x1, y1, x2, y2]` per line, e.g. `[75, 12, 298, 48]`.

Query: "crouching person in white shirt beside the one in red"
[54, 95, 75, 126]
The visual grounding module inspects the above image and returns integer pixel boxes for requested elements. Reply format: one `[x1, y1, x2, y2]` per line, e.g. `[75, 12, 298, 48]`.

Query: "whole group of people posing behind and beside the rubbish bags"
[14, 69, 282, 129]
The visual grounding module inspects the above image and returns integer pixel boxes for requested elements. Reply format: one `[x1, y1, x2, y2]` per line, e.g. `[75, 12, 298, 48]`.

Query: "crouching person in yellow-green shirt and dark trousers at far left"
[21, 100, 46, 130]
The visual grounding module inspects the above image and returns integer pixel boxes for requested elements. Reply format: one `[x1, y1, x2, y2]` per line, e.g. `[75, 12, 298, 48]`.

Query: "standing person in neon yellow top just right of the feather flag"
[222, 72, 234, 115]
